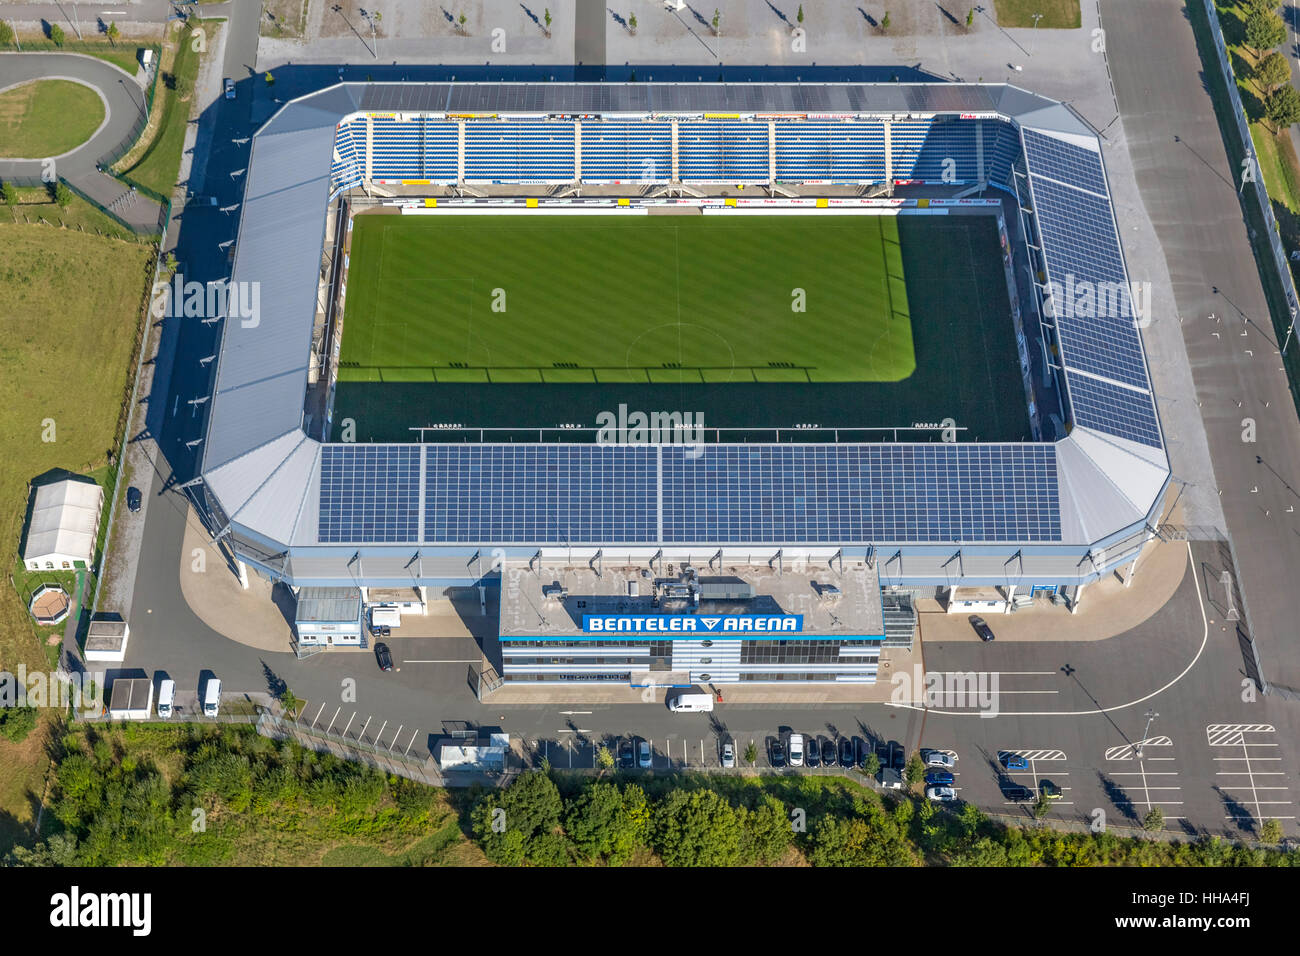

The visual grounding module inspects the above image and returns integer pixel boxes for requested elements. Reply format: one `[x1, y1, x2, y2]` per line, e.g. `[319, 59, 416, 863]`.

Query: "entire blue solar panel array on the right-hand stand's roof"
[1022, 129, 1161, 447]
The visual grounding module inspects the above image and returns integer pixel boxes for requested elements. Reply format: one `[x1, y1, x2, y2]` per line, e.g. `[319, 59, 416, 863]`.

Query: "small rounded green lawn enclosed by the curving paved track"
[0, 79, 104, 159]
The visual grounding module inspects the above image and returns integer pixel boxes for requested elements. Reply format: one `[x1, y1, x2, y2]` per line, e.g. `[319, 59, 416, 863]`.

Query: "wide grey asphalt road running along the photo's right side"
[1102, 0, 1300, 685]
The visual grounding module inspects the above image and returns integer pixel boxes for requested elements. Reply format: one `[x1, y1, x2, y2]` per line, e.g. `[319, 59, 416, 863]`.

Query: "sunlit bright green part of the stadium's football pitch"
[339, 215, 917, 384]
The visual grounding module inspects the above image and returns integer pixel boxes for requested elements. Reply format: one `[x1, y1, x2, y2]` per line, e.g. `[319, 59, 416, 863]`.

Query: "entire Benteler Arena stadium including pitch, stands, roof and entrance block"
[195, 83, 1169, 685]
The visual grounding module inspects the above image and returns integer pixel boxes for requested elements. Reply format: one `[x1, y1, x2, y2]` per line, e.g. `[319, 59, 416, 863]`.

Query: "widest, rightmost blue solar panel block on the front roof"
[663, 444, 1061, 544]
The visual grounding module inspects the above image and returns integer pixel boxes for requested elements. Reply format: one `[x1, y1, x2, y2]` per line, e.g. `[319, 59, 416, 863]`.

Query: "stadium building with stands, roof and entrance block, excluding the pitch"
[189, 83, 1170, 682]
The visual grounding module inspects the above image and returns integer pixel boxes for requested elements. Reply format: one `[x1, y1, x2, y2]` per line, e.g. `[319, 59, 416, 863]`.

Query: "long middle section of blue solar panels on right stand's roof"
[1031, 176, 1147, 389]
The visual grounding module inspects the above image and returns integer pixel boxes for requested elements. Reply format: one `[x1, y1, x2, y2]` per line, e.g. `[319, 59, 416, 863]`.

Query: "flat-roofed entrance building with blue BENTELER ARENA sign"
[499, 562, 889, 687]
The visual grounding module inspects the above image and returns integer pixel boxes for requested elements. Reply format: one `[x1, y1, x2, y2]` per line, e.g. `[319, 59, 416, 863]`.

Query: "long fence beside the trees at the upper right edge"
[1203, 0, 1300, 400]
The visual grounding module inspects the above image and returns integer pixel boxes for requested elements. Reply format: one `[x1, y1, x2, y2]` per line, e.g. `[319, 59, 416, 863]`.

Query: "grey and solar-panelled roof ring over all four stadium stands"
[202, 83, 1169, 583]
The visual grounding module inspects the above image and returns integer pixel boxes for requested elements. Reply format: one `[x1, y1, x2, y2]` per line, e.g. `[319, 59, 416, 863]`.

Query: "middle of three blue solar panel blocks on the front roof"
[424, 445, 658, 544]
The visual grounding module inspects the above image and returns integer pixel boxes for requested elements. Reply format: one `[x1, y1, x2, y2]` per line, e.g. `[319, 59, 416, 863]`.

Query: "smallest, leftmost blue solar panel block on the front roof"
[317, 445, 420, 544]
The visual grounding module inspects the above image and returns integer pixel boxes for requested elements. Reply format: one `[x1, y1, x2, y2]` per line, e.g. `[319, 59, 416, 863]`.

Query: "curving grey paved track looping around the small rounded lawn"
[0, 53, 163, 232]
